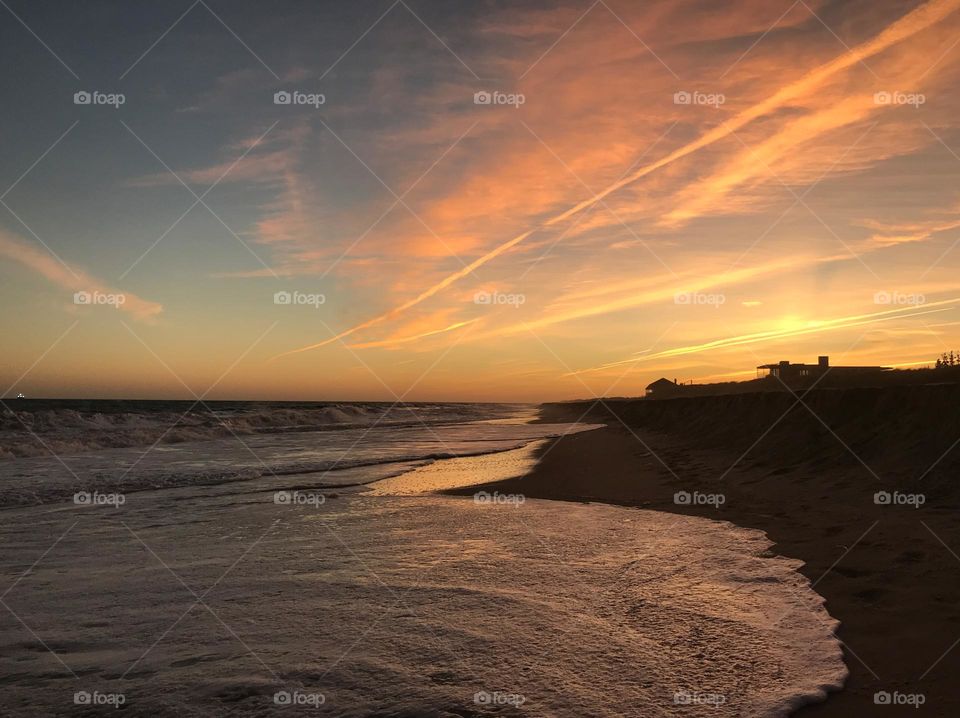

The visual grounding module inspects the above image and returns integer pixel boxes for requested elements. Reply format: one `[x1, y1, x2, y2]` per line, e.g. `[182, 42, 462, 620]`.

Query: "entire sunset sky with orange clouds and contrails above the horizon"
[0, 0, 960, 401]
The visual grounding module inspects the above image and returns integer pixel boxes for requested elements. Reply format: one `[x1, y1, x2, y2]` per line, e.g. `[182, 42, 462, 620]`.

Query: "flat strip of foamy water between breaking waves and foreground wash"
[0, 409, 592, 507]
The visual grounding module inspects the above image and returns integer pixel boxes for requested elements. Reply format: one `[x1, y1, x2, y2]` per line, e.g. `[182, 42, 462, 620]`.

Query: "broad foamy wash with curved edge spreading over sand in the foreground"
[0, 492, 846, 718]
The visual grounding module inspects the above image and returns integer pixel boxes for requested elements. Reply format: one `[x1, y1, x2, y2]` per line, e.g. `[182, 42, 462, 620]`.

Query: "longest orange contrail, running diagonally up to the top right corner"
[273, 0, 960, 359]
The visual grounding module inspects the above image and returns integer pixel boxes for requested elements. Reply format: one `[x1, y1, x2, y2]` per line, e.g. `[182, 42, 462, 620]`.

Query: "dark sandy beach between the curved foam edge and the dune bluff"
[446, 416, 960, 717]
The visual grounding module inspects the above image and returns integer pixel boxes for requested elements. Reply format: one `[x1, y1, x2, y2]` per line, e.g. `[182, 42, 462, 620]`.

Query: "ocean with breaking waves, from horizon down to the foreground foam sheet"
[0, 400, 584, 506]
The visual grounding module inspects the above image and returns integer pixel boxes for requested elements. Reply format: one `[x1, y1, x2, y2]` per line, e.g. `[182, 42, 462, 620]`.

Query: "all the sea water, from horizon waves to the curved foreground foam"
[0, 402, 846, 718]
